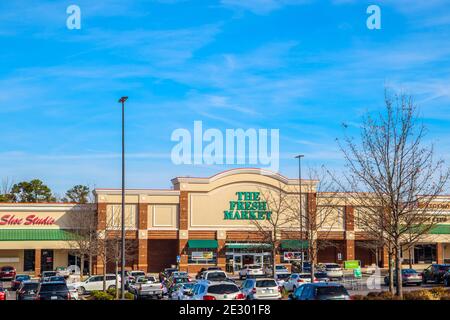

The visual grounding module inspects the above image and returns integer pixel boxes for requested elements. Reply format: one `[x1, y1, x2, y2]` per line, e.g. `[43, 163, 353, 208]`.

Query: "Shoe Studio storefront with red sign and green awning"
[0, 203, 94, 274]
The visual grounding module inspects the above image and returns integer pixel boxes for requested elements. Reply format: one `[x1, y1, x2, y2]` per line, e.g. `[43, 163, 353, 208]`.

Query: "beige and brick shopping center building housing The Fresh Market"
[0, 169, 450, 274]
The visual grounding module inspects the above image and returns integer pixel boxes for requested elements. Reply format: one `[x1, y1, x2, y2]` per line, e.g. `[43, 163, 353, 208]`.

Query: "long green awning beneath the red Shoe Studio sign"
[0, 229, 76, 241]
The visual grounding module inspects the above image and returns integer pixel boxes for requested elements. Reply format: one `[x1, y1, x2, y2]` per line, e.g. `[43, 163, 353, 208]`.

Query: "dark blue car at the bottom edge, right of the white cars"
[289, 282, 350, 300]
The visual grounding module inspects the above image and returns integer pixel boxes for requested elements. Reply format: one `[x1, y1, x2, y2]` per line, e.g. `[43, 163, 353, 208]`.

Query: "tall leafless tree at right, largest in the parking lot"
[337, 92, 449, 297]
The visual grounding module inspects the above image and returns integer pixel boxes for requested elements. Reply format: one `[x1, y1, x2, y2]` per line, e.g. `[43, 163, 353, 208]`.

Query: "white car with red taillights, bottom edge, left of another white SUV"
[188, 280, 245, 300]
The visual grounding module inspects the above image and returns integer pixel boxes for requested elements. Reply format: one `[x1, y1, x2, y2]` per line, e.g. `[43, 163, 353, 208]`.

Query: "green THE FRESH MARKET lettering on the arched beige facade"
[224, 192, 272, 220]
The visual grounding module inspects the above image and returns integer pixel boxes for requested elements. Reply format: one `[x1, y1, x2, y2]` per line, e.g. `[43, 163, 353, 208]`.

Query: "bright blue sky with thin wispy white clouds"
[0, 0, 450, 194]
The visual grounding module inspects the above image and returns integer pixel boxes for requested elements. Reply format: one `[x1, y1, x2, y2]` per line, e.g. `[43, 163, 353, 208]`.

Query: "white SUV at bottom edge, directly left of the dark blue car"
[241, 278, 281, 300]
